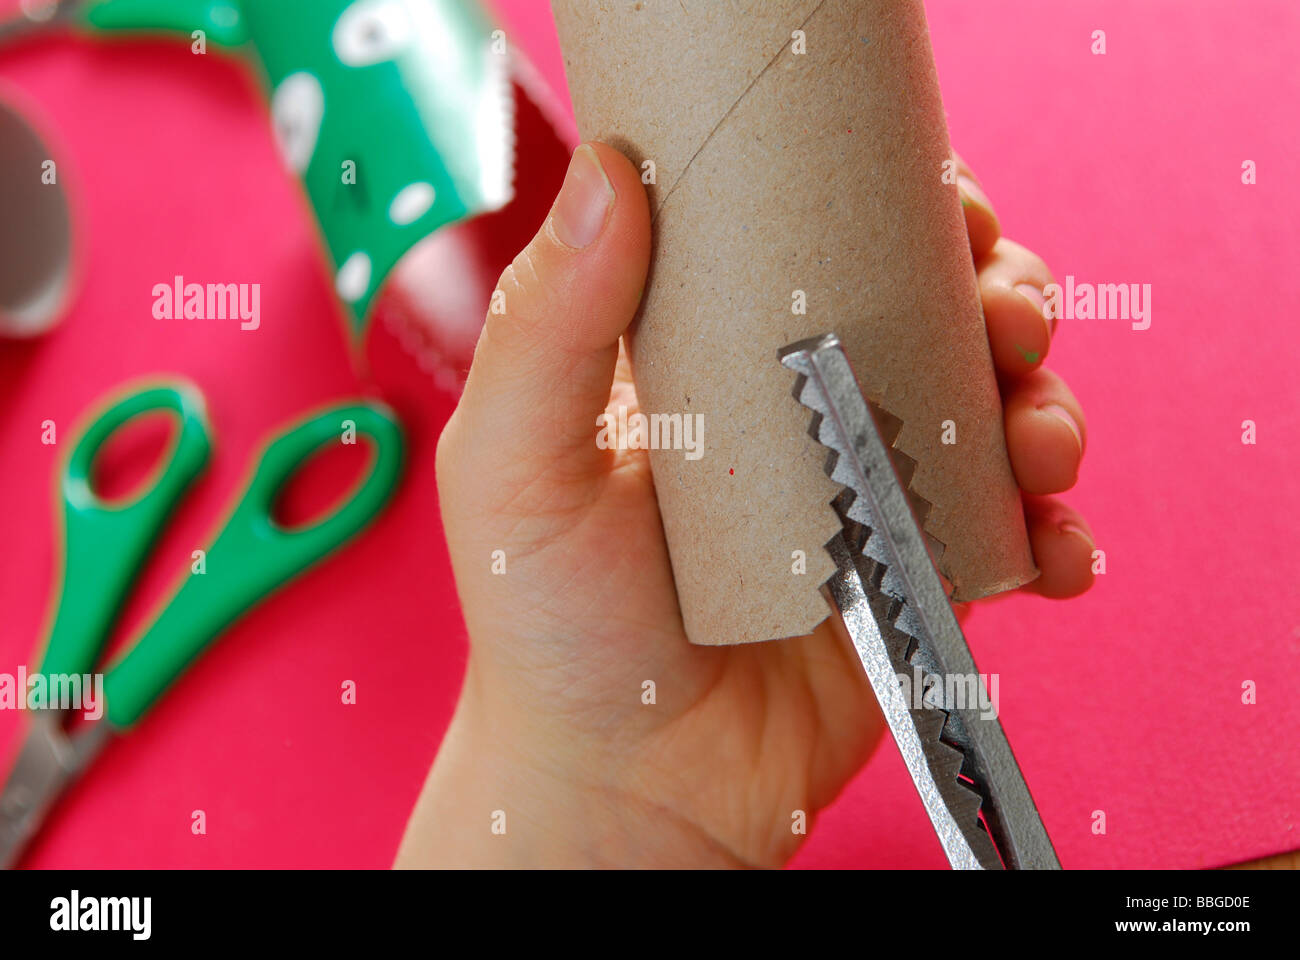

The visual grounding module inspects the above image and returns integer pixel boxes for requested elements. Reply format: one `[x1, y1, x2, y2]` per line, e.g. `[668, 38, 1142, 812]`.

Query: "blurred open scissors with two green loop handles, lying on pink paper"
[0, 380, 404, 868]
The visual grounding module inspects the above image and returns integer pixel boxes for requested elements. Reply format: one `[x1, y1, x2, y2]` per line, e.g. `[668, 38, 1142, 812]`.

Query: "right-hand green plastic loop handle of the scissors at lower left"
[104, 403, 404, 730]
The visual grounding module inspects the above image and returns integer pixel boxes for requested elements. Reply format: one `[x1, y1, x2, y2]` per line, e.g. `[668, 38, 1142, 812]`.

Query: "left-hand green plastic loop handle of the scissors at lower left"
[40, 381, 212, 697]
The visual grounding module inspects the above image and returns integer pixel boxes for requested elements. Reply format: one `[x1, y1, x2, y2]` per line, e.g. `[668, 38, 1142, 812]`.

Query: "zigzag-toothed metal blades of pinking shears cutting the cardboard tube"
[780, 334, 1060, 869]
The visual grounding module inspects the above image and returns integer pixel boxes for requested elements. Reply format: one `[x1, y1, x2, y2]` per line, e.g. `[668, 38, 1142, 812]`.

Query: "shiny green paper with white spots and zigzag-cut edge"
[68, 0, 515, 340]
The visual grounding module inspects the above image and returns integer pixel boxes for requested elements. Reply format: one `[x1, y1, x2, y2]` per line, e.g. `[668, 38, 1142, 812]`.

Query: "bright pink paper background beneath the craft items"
[0, 0, 1300, 866]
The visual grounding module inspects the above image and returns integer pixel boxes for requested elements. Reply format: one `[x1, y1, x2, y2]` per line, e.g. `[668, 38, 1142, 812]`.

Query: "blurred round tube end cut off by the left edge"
[0, 91, 73, 337]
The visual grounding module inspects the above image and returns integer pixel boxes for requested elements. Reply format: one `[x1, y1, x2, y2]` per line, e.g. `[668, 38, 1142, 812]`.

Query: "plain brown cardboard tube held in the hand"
[553, 0, 1037, 644]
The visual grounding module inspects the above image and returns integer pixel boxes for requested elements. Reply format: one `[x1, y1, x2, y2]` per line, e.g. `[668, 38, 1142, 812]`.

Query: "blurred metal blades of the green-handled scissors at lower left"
[0, 712, 108, 870]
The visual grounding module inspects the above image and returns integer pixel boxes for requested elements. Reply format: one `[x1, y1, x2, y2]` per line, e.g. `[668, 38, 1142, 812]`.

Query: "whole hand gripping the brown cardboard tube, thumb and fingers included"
[398, 143, 1093, 866]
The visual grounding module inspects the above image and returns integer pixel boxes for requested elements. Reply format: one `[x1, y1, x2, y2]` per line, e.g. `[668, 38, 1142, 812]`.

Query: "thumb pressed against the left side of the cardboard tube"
[456, 143, 650, 468]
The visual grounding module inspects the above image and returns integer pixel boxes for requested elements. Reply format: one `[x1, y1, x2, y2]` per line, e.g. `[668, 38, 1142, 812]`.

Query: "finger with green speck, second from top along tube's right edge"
[976, 237, 1052, 377]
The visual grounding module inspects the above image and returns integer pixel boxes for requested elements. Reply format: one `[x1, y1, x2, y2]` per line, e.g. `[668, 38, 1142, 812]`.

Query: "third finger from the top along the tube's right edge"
[1002, 368, 1088, 494]
